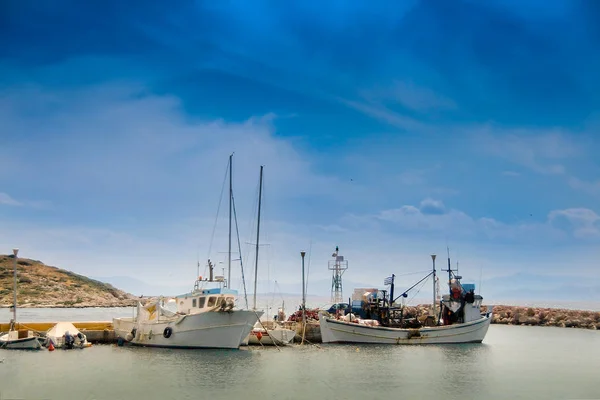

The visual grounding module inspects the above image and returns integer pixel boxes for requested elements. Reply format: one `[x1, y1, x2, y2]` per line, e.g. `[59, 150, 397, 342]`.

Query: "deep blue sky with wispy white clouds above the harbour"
[0, 0, 600, 300]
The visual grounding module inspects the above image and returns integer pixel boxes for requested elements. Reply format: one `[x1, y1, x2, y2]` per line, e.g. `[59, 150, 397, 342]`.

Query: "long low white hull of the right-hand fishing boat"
[319, 313, 492, 345]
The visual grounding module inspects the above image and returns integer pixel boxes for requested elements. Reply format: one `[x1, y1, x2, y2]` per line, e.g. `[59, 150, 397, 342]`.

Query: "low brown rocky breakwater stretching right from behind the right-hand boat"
[482, 305, 600, 329]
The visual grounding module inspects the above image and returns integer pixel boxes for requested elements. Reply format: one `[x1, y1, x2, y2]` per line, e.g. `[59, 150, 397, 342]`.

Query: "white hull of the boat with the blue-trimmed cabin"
[113, 310, 262, 349]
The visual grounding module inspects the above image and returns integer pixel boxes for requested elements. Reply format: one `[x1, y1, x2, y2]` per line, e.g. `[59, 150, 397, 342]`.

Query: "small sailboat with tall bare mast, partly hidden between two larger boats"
[247, 165, 296, 346]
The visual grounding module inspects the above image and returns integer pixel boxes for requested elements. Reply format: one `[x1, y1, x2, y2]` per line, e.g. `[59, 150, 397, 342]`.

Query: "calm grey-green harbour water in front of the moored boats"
[0, 325, 600, 400]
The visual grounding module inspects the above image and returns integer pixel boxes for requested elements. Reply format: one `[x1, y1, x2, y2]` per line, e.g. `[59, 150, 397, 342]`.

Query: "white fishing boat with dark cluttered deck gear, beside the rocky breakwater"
[319, 255, 492, 345]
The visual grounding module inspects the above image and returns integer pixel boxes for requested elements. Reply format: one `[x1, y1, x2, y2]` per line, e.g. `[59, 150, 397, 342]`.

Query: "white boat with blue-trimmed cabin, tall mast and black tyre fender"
[113, 154, 263, 349]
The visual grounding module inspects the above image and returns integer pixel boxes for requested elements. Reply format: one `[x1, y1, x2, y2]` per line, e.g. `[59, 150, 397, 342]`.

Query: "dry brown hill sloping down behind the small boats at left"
[0, 255, 136, 308]
